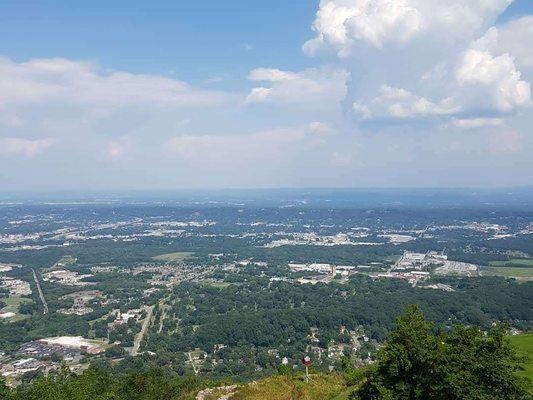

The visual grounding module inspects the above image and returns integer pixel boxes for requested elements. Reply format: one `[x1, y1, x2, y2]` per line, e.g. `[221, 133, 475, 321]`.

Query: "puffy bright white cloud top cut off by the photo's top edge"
[304, 0, 512, 57]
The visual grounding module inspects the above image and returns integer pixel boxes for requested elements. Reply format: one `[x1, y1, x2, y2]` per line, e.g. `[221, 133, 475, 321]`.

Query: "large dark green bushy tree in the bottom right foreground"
[352, 306, 529, 400]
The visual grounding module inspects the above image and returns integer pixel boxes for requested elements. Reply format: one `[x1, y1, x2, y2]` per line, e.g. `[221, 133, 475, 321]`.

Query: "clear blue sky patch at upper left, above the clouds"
[0, 0, 318, 85]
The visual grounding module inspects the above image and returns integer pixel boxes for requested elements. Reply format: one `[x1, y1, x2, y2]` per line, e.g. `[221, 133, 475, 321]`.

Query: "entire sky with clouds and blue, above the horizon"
[0, 0, 533, 192]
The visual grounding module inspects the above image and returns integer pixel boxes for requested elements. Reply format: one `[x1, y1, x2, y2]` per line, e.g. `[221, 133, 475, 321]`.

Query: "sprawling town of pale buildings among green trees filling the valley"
[0, 202, 533, 385]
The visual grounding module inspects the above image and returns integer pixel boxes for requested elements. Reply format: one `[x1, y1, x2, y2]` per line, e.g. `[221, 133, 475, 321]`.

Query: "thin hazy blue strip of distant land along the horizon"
[0, 187, 533, 210]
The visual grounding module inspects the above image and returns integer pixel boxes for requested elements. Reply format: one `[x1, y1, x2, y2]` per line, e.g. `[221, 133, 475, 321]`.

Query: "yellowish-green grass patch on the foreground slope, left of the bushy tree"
[232, 374, 347, 400]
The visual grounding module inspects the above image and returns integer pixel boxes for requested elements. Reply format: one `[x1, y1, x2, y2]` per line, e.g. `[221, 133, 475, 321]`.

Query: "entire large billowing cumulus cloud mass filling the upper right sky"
[304, 0, 533, 126]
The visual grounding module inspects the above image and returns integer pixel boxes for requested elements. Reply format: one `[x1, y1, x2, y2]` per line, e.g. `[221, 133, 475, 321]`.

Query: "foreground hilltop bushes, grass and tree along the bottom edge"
[0, 306, 531, 400]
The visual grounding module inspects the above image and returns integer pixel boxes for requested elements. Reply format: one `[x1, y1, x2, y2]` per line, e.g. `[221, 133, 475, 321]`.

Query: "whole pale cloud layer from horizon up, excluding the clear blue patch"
[0, 0, 533, 188]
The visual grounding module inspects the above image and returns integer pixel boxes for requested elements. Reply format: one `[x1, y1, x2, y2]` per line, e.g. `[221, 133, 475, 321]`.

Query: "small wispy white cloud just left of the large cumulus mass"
[246, 68, 349, 108]
